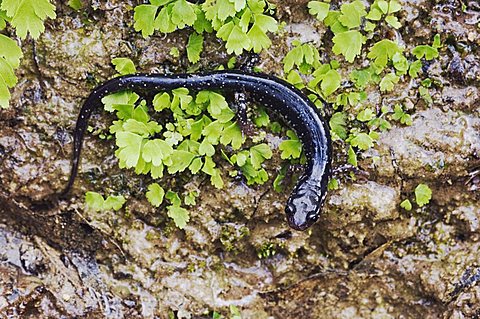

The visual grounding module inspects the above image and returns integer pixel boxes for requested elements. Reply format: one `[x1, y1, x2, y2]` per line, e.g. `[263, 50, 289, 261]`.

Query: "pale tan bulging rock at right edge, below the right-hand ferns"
[376, 109, 480, 181]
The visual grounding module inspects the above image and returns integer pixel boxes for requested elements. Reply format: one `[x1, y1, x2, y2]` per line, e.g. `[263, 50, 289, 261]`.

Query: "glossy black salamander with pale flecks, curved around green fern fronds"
[64, 71, 331, 230]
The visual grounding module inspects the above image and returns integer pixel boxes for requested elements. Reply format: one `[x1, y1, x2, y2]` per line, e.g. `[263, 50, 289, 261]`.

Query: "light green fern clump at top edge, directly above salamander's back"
[134, 0, 278, 63]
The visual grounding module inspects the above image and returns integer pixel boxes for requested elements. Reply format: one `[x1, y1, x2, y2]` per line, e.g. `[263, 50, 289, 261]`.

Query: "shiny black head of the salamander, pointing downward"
[285, 184, 325, 230]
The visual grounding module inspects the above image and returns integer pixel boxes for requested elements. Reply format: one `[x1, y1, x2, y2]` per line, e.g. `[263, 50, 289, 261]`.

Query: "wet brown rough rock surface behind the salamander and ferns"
[0, 0, 480, 318]
